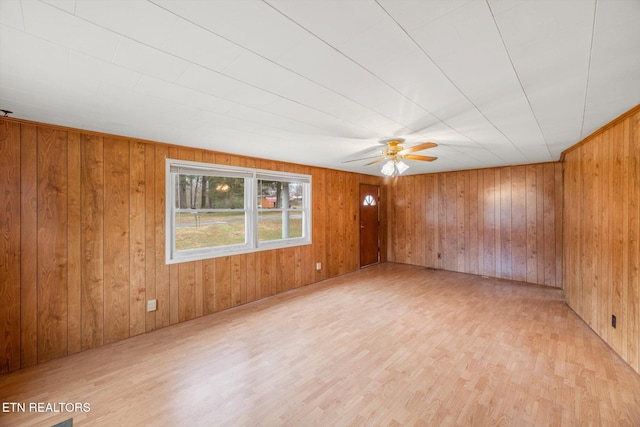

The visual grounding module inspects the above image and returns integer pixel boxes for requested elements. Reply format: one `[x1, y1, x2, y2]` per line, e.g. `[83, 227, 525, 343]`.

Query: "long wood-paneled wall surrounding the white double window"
[0, 119, 386, 373]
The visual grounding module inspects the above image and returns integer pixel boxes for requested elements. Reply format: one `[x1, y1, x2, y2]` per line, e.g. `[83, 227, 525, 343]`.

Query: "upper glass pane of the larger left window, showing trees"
[176, 175, 244, 209]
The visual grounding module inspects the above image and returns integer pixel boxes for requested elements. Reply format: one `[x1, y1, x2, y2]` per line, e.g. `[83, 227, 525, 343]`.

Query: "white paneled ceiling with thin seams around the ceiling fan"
[0, 0, 640, 175]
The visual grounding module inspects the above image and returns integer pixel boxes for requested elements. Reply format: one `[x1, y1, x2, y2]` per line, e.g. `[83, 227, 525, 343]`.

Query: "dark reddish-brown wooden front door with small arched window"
[360, 184, 380, 267]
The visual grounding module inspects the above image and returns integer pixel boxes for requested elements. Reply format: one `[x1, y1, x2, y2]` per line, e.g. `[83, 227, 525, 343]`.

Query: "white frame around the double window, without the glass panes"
[165, 159, 312, 264]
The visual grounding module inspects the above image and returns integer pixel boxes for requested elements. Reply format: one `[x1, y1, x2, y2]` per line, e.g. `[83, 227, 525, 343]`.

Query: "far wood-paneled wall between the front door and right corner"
[388, 163, 562, 288]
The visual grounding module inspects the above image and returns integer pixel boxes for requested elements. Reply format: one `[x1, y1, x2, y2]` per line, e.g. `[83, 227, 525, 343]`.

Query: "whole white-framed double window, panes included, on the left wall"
[166, 159, 311, 263]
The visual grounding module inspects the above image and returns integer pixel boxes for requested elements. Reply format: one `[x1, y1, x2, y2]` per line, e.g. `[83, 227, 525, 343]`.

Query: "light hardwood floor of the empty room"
[0, 263, 640, 426]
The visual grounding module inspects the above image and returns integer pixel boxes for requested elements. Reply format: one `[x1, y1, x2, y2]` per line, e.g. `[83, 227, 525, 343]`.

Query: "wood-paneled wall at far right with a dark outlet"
[563, 106, 640, 373]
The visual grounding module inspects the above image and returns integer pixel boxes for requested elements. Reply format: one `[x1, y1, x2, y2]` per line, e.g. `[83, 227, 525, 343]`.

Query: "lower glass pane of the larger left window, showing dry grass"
[176, 212, 246, 251]
